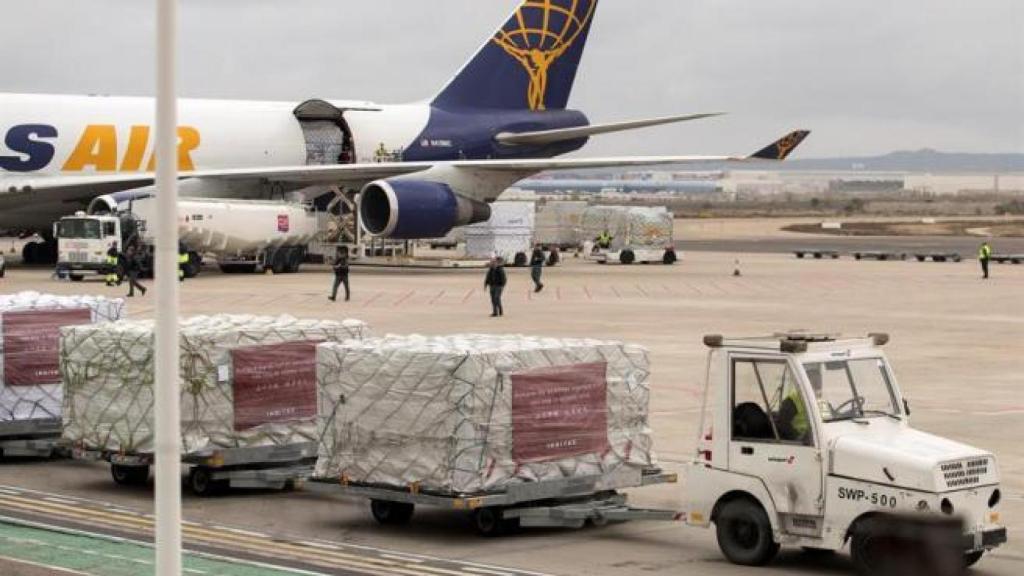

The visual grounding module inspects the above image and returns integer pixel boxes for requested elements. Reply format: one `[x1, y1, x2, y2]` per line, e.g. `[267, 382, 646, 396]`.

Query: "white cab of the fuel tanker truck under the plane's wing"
[53, 211, 123, 281]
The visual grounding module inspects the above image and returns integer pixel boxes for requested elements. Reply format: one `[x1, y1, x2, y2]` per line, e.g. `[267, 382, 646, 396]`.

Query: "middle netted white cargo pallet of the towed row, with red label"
[60, 316, 368, 454]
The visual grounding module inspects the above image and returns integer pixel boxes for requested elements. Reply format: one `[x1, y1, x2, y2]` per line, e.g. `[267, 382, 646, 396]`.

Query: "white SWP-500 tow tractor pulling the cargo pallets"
[686, 334, 1007, 574]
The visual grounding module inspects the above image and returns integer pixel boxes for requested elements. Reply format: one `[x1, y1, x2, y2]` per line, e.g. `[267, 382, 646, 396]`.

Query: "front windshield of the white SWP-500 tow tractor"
[804, 358, 900, 422]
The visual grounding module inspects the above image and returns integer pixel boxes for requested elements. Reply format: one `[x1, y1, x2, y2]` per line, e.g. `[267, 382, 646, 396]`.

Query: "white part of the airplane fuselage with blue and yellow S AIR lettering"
[0, 94, 430, 177]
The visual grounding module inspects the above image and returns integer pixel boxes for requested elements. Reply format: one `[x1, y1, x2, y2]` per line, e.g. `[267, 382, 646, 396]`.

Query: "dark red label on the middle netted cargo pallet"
[231, 342, 319, 431]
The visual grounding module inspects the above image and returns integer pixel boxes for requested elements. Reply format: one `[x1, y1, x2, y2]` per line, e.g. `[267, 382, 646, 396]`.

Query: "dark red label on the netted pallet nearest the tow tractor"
[512, 362, 608, 462]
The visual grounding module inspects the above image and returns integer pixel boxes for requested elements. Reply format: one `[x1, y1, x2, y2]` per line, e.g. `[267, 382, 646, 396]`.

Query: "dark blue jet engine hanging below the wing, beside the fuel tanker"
[359, 179, 490, 235]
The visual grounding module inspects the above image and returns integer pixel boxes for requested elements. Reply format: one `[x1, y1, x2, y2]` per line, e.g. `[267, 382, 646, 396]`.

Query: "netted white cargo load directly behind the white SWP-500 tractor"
[315, 335, 655, 494]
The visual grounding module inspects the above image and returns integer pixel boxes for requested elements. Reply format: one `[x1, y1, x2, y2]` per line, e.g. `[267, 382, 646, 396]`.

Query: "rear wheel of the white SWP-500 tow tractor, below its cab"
[715, 499, 778, 566]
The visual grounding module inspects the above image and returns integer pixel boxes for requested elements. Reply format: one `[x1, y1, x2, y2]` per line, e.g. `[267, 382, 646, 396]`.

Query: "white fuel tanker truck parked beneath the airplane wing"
[53, 195, 316, 281]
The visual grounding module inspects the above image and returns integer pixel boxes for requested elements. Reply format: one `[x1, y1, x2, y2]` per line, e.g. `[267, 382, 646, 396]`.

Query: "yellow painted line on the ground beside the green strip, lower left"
[0, 495, 487, 576]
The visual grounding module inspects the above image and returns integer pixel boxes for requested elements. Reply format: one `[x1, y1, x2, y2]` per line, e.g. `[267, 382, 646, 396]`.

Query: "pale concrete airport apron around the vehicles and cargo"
[0, 225, 1024, 576]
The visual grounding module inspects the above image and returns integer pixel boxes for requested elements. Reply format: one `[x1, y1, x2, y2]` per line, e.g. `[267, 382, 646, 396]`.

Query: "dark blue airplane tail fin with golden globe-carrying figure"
[432, 0, 598, 111]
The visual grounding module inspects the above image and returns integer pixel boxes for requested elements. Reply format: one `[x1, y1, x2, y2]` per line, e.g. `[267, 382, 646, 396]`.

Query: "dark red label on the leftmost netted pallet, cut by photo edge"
[3, 308, 92, 386]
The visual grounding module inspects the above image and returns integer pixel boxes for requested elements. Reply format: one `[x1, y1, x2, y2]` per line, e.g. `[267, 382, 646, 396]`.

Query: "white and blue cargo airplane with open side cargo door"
[0, 0, 807, 262]
